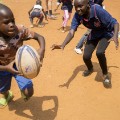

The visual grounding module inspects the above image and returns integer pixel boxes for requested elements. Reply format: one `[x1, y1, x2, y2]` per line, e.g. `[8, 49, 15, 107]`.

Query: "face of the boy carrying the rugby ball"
[0, 9, 16, 37]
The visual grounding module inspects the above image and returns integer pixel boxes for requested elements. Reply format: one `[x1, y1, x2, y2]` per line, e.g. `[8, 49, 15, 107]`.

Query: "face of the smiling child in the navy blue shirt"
[74, 0, 89, 16]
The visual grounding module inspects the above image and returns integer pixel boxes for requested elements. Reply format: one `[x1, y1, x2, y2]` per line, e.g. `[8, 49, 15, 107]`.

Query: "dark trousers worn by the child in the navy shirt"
[83, 38, 109, 75]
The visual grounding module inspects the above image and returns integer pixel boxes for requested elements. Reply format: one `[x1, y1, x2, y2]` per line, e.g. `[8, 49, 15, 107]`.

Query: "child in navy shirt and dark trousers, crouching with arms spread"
[52, 0, 119, 87]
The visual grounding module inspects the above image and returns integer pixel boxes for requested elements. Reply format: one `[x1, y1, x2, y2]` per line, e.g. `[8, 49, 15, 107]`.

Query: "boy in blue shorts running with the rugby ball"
[0, 4, 45, 107]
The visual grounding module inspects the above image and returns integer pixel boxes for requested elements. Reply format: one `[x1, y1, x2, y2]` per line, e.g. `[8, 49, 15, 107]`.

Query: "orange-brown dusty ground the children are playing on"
[0, 0, 120, 120]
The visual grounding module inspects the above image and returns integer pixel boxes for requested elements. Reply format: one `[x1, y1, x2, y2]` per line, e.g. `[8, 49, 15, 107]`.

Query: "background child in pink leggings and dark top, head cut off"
[55, 0, 73, 32]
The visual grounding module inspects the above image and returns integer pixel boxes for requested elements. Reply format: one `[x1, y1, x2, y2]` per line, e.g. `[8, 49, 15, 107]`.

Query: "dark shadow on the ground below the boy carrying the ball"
[8, 96, 58, 120]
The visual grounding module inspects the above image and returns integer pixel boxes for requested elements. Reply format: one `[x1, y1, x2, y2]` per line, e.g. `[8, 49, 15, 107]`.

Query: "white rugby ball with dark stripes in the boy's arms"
[15, 45, 41, 79]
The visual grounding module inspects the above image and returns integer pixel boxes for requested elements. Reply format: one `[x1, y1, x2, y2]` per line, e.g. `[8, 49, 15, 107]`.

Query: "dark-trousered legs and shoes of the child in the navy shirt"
[83, 38, 111, 87]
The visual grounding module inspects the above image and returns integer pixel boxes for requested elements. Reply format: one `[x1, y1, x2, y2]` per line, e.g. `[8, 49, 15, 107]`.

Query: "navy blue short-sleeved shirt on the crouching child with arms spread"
[71, 4, 117, 40]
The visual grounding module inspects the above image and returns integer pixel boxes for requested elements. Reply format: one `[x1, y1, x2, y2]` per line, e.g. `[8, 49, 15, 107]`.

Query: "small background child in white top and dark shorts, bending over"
[28, 0, 47, 28]
